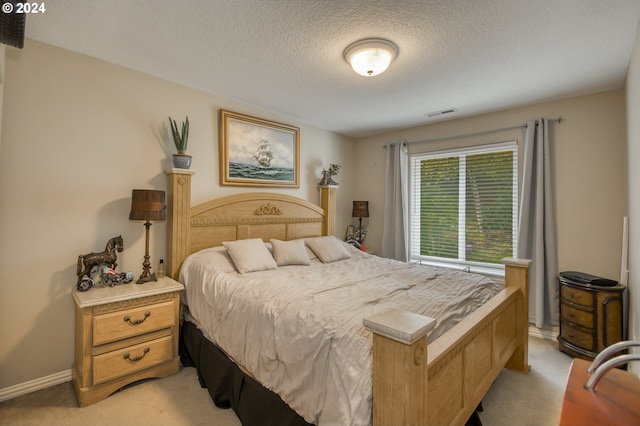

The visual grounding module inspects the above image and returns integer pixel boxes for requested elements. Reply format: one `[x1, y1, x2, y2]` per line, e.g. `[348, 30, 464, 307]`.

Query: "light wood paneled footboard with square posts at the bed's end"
[365, 259, 531, 426]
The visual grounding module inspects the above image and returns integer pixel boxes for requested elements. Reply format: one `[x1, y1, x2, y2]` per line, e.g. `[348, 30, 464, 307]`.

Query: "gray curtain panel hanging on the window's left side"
[382, 142, 409, 261]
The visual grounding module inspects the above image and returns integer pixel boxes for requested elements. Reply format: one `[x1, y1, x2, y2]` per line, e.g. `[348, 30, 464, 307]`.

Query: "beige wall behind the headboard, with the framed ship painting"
[0, 40, 356, 390]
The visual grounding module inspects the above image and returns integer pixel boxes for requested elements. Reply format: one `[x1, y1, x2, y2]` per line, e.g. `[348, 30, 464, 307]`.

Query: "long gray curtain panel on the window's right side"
[518, 118, 559, 327]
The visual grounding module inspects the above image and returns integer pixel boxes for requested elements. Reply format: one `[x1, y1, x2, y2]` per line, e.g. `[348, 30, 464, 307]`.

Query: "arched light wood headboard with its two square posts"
[165, 169, 336, 280]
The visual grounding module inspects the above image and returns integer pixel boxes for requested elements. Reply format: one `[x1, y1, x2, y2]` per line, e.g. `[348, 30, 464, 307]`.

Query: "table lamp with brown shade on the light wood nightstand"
[129, 189, 167, 284]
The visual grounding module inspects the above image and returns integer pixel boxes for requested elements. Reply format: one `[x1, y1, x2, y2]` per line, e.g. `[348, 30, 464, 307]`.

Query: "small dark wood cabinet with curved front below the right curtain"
[558, 277, 626, 360]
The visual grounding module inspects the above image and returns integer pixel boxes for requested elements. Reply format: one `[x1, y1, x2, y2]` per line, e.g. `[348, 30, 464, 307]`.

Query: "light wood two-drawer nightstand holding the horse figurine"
[73, 277, 184, 407]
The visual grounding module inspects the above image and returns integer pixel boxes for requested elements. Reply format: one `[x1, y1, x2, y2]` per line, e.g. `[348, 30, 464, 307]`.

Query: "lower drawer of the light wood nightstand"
[93, 336, 173, 385]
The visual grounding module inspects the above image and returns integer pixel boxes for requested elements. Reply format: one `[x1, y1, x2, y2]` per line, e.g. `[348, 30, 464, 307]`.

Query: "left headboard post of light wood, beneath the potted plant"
[165, 168, 195, 280]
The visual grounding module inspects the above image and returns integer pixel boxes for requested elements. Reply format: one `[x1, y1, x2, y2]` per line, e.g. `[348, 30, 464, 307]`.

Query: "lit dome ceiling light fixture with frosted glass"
[344, 38, 398, 77]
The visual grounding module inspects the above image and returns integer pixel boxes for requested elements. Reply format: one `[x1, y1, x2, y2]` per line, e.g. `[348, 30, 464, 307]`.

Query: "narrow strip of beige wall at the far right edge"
[626, 20, 640, 366]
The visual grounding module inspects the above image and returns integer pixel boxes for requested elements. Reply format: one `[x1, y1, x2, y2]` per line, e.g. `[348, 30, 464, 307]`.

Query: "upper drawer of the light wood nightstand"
[93, 301, 176, 346]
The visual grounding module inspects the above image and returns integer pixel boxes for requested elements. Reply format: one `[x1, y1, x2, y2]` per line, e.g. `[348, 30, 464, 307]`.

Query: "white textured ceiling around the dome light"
[22, 0, 640, 137]
